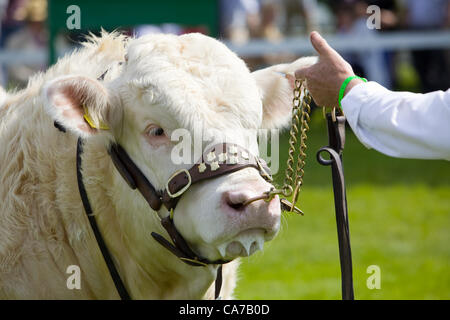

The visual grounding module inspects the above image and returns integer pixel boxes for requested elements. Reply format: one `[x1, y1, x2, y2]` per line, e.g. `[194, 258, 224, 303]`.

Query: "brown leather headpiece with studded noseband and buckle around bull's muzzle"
[109, 143, 272, 266]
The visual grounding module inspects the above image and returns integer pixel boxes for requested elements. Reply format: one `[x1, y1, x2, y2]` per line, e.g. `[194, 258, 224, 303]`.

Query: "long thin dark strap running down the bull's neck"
[76, 138, 130, 300]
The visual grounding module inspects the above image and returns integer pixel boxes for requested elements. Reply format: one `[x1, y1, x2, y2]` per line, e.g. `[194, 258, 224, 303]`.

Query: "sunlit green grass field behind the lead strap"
[236, 112, 450, 299]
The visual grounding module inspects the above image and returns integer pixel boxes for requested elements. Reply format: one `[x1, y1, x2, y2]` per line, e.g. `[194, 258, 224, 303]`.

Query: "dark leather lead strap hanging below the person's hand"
[316, 114, 354, 300]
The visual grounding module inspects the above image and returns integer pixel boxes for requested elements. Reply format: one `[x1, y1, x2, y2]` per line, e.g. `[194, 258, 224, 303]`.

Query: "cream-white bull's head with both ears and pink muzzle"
[44, 34, 314, 266]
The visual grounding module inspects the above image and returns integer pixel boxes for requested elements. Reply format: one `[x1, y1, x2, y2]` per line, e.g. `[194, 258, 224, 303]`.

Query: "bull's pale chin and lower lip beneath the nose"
[217, 228, 265, 260]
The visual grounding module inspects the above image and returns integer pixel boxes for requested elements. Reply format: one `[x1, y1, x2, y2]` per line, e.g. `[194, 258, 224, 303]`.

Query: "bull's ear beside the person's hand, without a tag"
[253, 57, 317, 129]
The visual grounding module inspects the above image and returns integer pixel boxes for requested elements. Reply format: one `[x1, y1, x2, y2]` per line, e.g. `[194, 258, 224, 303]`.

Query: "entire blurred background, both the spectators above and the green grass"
[0, 0, 450, 299]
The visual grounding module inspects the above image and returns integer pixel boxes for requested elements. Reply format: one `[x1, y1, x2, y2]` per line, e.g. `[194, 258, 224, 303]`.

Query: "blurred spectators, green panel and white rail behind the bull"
[0, 0, 450, 92]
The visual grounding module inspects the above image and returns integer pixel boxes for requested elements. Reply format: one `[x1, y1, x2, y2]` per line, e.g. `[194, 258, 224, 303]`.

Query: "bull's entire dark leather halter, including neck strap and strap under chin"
[59, 117, 272, 300]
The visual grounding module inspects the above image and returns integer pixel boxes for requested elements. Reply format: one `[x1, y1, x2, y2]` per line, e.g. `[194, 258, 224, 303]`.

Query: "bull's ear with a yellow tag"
[42, 76, 118, 137]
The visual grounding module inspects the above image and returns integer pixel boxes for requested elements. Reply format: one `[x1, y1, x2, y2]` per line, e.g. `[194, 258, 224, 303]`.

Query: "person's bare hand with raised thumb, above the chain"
[295, 31, 363, 107]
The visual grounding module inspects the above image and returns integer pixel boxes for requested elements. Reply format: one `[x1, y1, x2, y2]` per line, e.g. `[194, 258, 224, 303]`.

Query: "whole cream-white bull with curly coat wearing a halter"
[0, 34, 314, 299]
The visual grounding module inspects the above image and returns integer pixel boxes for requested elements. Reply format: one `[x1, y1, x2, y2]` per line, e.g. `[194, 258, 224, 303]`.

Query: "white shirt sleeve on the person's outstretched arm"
[341, 82, 450, 160]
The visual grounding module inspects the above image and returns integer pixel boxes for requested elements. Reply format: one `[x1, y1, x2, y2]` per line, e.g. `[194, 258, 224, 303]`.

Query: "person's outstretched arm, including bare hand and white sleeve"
[296, 32, 450, 160]
